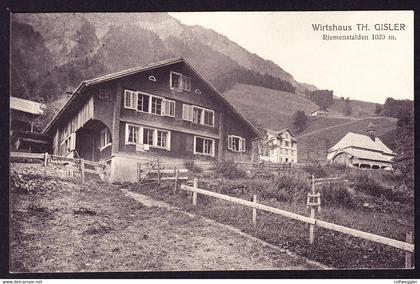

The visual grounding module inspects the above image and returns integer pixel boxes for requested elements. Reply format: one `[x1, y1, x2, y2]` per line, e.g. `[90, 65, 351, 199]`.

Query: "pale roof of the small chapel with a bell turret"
[328, 132, 395, 158]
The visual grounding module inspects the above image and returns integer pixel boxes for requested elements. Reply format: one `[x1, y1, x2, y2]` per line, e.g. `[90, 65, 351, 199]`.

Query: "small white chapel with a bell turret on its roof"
[327, 123, 396, 169]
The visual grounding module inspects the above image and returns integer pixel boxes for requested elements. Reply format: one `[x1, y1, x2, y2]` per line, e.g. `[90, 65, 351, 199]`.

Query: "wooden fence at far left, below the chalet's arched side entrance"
[10, 152, 109, 182]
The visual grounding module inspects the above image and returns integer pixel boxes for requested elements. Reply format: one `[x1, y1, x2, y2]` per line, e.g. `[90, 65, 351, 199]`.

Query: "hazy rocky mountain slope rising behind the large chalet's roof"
[11, 13, 316, 102]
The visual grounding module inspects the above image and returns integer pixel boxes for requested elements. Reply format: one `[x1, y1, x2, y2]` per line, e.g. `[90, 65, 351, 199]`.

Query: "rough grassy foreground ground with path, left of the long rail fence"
[10, 165, 320, 272]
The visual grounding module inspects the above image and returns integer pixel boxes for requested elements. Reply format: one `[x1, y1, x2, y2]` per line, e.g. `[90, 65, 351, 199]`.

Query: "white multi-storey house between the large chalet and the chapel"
[260, 128, 297, 163]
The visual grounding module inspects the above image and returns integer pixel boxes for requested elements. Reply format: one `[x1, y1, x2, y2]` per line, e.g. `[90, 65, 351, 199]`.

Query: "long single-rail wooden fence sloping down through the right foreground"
[181, 179, 414, 268]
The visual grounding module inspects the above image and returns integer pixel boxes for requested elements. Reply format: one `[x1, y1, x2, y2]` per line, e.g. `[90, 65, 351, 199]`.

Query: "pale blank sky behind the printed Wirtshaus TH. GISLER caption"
[170, 11, 414, 103]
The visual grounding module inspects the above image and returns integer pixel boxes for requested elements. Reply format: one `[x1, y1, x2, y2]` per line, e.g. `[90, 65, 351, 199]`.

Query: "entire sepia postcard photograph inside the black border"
[6, 10, 416, 275]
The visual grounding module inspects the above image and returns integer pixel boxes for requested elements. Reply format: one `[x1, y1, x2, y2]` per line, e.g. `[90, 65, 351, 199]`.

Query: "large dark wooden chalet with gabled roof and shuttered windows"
[45, 58, 259, 181]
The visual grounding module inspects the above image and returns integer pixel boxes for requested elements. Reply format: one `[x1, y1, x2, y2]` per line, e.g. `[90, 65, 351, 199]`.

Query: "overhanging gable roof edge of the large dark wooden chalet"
[43, 57, 261, 136]
